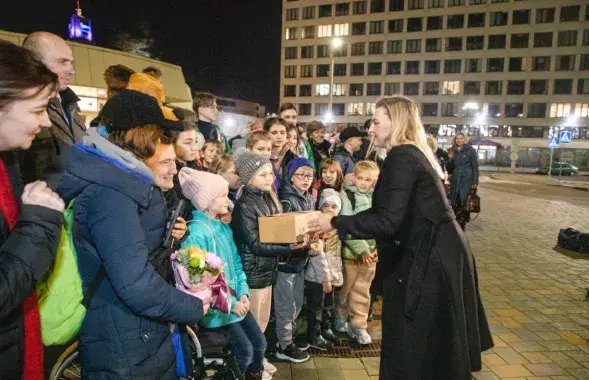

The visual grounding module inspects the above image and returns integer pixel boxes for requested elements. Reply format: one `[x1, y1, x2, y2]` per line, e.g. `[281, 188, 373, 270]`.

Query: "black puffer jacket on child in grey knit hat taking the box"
[231, 186, 290, 289]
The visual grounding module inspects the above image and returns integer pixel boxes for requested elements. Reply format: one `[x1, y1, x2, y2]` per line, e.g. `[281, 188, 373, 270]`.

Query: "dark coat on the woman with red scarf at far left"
[0, 152, 63, 379]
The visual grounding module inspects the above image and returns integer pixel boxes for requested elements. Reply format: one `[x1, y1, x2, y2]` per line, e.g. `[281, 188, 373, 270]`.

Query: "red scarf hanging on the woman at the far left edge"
[0, 159, 44, 380]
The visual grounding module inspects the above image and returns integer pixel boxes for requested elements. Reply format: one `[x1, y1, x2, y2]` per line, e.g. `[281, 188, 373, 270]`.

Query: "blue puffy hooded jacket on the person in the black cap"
[58, 132, 203, 380]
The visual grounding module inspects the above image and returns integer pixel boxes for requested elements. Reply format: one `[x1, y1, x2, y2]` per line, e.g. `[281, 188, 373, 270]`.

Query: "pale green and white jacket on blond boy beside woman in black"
[340, 185, 376, 260]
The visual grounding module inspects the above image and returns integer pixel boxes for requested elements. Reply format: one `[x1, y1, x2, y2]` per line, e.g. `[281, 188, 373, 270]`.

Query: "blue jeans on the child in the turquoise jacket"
[225, 313, 266, 374]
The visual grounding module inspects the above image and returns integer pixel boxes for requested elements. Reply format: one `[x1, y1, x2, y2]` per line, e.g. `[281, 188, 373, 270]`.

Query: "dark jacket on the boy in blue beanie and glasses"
[278, 182, 315, 273]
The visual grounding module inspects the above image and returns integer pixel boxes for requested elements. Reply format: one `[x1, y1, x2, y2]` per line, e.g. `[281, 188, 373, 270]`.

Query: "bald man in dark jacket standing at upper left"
[21, 32, 86, 190]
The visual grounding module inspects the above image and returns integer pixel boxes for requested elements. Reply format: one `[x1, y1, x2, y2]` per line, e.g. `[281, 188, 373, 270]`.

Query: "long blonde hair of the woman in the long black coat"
[376, 95, 444, 178]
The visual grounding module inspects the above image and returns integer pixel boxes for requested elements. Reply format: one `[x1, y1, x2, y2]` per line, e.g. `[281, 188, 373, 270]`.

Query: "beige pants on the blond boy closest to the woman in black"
[334, 260, 376, 330]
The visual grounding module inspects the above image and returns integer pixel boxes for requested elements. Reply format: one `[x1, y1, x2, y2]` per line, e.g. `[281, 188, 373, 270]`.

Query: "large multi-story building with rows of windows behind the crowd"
[280, 0, 589, 166]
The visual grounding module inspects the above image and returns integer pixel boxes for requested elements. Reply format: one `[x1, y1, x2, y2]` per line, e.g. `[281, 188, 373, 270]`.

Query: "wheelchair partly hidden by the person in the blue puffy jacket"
[49, 326, 241, 380]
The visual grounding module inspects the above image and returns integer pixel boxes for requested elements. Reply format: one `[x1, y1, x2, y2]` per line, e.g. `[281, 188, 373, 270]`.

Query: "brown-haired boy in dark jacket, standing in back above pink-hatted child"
[192, 92, 231, 154]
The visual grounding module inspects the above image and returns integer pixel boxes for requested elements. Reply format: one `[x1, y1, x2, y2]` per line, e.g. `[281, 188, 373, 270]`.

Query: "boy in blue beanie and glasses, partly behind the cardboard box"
[274, 157, 320, 363]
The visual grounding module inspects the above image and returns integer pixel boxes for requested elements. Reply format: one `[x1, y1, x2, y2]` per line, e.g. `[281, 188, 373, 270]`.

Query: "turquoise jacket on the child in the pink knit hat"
[182, 211, 249, 328]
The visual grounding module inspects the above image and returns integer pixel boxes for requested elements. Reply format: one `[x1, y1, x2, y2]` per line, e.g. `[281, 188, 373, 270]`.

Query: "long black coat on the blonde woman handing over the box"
[334, 145, 493, 380]
